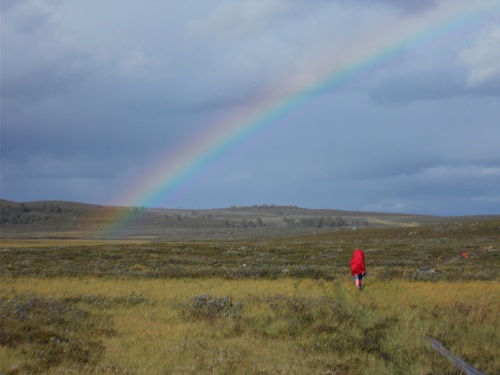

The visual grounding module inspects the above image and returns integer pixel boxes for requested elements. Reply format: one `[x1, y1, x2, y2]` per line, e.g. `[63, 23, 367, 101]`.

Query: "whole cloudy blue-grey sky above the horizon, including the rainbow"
[0, 0, 500, 216]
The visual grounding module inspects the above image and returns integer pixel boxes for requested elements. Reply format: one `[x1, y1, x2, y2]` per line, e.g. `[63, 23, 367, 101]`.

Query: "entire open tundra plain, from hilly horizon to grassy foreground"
[0, 201, 500, 374]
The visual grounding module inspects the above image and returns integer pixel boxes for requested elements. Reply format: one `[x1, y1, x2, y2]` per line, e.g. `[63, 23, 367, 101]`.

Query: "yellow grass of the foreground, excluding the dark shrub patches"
[0, 278, 500, 374]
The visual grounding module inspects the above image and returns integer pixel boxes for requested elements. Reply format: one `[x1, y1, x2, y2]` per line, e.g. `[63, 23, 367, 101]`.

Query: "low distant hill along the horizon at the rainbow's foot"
[0, 200, 500, 240]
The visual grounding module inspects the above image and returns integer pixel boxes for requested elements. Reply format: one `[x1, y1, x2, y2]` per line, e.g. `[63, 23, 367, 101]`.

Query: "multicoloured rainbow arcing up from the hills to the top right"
[96, 0, 500, 236]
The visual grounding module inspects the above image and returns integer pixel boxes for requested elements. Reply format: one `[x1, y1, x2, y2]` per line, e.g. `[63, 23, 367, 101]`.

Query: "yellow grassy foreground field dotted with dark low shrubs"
[0, 278, 500, 374]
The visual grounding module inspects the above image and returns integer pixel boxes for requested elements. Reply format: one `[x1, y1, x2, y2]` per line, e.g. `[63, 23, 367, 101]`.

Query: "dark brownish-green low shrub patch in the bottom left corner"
[0, 295, 114, 373]
